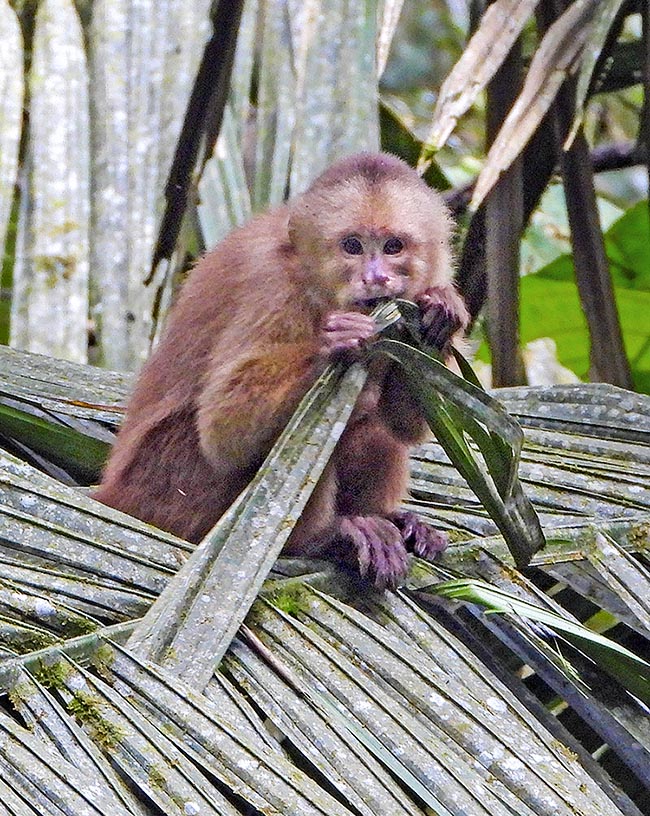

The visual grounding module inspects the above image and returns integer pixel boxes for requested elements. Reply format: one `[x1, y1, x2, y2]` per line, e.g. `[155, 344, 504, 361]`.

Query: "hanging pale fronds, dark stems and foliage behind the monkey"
[0, 0, 650, 392]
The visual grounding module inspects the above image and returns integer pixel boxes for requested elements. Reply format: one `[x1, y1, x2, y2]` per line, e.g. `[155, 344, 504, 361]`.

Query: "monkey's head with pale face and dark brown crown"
[289, 153, 452, 311]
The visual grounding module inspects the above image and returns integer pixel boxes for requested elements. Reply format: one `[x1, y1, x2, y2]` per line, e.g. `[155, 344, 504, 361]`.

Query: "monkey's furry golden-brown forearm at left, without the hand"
[197, 341, 323, 468]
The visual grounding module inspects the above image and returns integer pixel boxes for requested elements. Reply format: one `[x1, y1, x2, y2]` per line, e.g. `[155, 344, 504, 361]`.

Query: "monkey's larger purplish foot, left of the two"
[339, 516, 408, 589]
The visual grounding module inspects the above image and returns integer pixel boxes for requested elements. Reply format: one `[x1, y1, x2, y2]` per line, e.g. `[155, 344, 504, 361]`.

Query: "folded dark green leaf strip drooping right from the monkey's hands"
[371, 338, 545, 568]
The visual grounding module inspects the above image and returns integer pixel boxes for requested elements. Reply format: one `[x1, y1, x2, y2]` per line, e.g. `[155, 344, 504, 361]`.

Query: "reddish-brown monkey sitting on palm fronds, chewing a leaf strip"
[94, 153, 469, 588]
